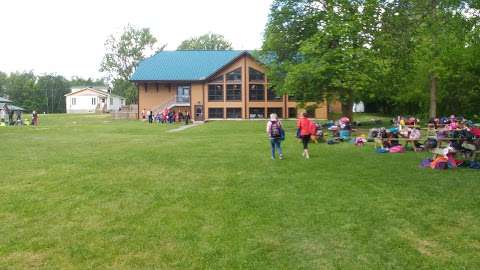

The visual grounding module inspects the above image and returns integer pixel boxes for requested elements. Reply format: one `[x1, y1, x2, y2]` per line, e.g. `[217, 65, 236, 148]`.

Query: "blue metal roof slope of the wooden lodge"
[130, 51, 248, 81]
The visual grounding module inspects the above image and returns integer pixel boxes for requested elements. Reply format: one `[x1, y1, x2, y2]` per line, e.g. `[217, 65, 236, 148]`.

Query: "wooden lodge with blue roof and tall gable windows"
[131, 51, 337, 121]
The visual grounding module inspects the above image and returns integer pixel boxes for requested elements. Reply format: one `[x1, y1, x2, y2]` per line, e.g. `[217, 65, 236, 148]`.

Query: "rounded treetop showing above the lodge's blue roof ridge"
[177, 33, 233, 51]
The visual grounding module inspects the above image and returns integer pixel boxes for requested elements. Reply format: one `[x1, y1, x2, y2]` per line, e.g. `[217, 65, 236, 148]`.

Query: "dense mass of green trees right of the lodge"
[262, 0, 480, 117]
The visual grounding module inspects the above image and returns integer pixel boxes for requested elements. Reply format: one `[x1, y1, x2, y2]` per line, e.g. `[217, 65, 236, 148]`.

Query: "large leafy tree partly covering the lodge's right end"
[264, 0, 378, 117]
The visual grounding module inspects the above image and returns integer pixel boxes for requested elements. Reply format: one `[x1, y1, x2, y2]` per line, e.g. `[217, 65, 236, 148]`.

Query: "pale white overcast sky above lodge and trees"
[0, 0, 272, 78]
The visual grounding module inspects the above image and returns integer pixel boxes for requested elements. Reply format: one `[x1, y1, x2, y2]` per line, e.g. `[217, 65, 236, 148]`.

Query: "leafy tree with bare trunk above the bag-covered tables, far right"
[374, 0, 478, 116]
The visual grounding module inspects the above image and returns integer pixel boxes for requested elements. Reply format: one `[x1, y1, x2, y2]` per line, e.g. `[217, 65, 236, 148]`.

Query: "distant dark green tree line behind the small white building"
[0, 71, 104, 113]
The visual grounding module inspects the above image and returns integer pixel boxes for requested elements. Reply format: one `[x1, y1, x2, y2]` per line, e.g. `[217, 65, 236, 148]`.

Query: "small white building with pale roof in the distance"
[65, 87, 125, 113]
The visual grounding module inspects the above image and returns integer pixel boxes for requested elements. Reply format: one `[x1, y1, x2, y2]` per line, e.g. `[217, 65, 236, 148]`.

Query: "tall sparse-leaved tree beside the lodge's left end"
[100, 25, 165, 103]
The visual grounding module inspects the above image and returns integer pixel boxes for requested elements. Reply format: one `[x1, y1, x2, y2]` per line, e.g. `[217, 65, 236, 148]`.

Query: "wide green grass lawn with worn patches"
[0, 115, 480, 269]
